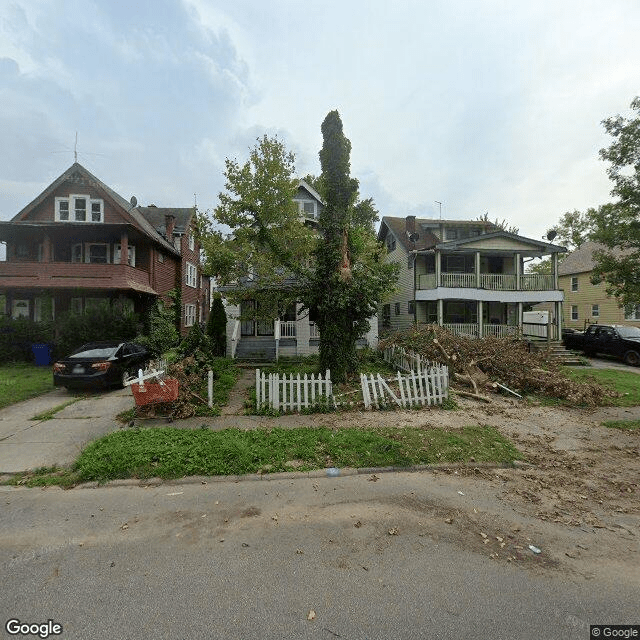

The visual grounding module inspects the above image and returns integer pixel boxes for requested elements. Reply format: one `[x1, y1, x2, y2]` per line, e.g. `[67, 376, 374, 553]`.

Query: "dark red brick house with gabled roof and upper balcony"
[0, 162, 209, 334]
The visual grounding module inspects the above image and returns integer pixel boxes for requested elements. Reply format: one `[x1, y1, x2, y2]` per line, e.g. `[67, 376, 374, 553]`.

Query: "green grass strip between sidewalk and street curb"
[5, 426, 523, 486]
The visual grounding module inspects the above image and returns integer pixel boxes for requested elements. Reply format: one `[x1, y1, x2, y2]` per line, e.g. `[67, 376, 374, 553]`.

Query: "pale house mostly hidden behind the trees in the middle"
[220, 180, 378, 360]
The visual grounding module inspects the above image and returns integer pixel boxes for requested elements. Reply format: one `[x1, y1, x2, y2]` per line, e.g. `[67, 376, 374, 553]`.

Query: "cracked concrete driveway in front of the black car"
[0, 388, 134, 474]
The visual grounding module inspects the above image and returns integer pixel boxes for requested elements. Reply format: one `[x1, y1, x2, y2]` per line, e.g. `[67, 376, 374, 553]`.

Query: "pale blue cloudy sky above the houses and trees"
[0, 0, 640, 237]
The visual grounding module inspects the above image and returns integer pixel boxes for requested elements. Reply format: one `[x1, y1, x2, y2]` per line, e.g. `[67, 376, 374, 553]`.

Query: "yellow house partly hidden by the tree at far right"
[558, 242, 640, 330]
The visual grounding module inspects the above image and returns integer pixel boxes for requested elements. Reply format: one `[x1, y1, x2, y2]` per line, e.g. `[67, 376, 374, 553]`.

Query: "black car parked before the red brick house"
[53, 340, 150, 389]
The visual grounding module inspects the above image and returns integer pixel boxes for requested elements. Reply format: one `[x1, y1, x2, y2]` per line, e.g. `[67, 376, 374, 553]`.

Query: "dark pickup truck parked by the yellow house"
[562, 324, 640, 367]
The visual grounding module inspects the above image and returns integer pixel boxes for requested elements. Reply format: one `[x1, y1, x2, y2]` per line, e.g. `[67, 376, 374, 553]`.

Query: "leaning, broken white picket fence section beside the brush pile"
[360, 365, 449, 409]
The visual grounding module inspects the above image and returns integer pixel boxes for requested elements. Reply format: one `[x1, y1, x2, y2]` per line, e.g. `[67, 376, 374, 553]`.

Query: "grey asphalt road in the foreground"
[0, 473, 640, 640]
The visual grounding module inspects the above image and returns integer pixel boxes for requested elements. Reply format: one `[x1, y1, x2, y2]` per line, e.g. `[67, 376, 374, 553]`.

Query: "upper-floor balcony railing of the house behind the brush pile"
[417, 273, 555, 291]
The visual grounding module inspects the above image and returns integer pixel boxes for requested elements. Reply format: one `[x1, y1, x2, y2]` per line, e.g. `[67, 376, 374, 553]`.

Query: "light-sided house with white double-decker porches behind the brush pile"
[378, 216, 566, 336]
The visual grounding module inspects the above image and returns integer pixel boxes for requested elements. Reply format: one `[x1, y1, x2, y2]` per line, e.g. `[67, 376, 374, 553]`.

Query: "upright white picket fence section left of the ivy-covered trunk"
[256, 369, 335, 412]
